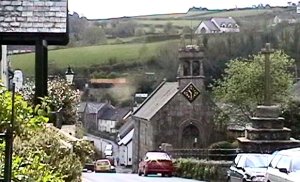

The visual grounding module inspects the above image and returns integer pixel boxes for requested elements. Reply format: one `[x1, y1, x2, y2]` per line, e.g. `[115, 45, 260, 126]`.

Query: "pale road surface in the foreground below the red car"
[82, 173, 205, 182]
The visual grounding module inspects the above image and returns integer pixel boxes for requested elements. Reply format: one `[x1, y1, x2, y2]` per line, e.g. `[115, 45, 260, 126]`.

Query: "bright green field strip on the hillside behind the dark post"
[10, 41, 177, 76]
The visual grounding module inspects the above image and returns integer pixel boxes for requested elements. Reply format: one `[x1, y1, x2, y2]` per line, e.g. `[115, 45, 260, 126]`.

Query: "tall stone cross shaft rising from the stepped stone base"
[261, 43, 274, 106]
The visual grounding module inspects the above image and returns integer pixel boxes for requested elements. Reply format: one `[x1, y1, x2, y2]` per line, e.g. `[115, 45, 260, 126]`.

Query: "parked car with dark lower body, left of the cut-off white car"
[227, 153, 272, 182]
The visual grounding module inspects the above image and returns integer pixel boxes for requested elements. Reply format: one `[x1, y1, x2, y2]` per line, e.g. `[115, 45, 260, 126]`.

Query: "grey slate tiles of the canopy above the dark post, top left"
[0, 0, 68, 33]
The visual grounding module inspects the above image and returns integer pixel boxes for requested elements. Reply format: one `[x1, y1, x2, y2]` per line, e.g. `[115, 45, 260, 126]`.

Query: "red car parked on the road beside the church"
[138, 152, 174, 177]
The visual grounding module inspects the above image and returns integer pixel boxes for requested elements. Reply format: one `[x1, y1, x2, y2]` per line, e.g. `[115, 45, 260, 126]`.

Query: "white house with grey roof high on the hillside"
[195, 17, 240, 34]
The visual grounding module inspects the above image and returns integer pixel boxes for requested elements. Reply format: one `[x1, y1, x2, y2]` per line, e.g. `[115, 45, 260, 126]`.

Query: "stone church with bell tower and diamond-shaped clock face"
[132, 45, 217, 170]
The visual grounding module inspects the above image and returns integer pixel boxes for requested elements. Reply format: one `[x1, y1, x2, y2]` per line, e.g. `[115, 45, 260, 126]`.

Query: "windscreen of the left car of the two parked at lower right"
[245, 155, 270, 168]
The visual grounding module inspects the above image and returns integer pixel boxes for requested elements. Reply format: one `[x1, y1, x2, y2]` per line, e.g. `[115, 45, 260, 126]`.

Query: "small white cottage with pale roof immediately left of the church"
[118, 129, 134, 166]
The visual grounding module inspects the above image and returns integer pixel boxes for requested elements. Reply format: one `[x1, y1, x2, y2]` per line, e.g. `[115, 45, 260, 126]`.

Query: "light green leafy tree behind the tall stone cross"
[213, 51, 294, 119]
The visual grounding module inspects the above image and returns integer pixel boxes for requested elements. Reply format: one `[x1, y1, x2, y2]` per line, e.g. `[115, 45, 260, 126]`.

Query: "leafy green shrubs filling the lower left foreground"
[0, 84, 94, 182]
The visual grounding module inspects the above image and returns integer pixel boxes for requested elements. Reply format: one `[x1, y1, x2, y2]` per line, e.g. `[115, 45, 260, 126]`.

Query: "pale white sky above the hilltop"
[68, 0, 292, 19]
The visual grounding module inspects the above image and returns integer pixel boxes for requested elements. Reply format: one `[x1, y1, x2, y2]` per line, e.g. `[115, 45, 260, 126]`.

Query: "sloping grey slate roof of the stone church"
[133, 82, 178, 121]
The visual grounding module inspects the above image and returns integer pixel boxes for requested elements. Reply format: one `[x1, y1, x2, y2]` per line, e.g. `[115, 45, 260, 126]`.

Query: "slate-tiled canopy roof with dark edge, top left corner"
[0, 0, 69, 45]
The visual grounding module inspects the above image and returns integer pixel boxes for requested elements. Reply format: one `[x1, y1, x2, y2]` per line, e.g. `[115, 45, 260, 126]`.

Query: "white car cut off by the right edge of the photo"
[266, 148, 300, 182]
